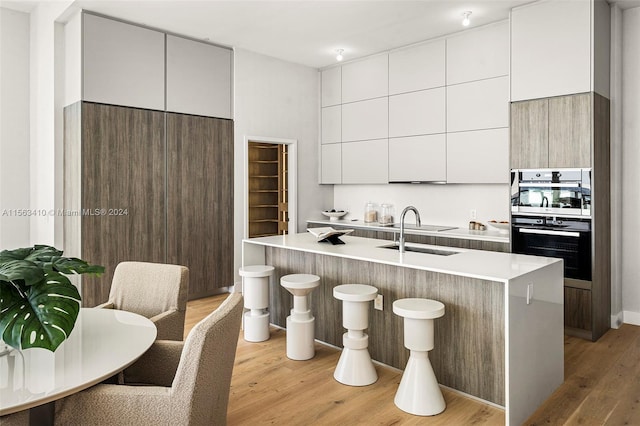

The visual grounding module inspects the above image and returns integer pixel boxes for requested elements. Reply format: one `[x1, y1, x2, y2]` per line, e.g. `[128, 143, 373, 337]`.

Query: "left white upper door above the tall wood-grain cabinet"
[82, 13, 165, 110]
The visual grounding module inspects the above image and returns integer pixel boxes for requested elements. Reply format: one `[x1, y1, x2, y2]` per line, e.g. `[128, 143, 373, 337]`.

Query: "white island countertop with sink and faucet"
[244, 232, 562, 282]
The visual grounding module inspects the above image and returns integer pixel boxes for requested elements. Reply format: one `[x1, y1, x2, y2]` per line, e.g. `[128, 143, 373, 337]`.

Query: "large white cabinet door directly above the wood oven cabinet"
[511, 1, 591, 101]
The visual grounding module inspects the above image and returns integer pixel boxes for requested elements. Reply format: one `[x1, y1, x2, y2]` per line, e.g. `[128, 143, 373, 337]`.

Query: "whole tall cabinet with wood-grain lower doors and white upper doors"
[64, 12, 234, 306]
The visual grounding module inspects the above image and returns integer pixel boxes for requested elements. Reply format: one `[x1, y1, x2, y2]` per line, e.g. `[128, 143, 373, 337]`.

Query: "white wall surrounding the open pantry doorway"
[234, 49, 333, 279]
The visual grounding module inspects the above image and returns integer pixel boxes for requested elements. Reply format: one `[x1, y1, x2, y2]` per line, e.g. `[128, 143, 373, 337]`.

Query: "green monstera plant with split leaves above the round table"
[0, 245, 104, 351]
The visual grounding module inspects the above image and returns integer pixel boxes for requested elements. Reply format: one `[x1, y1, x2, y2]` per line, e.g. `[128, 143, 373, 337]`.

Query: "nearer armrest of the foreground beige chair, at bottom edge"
[55, 385, 172, 425]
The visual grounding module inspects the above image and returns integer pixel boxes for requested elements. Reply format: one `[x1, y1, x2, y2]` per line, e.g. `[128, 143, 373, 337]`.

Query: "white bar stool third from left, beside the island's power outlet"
[333, 284, 378, 386]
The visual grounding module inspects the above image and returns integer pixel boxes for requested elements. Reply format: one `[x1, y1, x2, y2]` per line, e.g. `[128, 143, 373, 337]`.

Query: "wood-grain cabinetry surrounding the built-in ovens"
[511, 92, 611, 341]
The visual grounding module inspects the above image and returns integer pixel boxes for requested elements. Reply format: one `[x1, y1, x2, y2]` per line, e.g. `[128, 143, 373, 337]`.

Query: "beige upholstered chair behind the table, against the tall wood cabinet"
[96, 262, 189, 340]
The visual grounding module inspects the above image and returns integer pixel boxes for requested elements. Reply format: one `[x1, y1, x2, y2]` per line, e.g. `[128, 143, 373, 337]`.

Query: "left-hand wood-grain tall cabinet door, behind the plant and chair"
[78, 102, 165, 306]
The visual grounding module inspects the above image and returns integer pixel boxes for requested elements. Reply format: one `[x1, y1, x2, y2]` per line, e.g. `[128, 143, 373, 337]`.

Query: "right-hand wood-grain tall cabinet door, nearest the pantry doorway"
[166, 113, 234, 299]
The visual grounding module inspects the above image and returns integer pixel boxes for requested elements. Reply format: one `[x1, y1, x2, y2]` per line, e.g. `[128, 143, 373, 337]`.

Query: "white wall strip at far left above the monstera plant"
[0, 8, 30, 250]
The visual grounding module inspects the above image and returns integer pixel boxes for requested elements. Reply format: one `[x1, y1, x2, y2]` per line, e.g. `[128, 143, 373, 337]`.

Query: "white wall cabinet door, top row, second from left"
[342, 53, 389, 103]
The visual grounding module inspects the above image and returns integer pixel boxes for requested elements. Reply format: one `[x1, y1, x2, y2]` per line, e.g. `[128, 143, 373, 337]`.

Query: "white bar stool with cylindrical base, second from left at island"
[280, 274, 320, 361]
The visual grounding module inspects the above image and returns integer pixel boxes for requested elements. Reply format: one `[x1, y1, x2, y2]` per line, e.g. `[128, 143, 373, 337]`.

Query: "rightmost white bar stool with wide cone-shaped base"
[393, 299, 446, 416]
